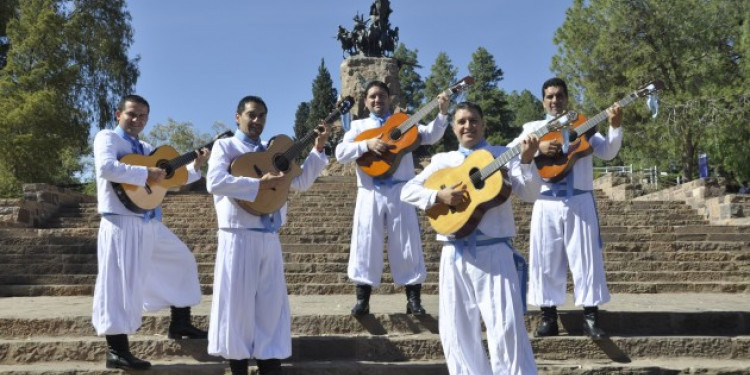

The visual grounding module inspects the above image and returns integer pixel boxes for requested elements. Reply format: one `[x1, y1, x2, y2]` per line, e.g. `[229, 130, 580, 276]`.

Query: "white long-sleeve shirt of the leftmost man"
[94, 129, 201, 216]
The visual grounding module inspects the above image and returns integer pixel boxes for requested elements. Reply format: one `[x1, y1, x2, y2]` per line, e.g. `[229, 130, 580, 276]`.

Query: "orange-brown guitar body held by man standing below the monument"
[354, 113, 420, 178]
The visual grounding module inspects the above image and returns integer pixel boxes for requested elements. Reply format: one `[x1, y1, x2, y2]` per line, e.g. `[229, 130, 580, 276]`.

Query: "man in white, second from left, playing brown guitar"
[206, 95, 329, 375]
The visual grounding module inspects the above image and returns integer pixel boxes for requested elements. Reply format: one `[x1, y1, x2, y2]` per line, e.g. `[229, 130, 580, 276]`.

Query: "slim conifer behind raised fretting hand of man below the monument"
[424, 52, 458, 152]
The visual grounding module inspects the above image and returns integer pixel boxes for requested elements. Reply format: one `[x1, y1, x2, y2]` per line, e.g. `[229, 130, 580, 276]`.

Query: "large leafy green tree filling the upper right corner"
[552, 0, 750, 182]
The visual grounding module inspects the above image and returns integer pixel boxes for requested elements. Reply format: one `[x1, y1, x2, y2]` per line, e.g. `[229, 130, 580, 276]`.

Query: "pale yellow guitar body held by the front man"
[424, 150, 511, 238]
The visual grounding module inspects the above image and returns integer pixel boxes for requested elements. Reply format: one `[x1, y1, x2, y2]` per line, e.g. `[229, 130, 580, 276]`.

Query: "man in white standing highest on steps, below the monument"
[336, 81, 450, 316]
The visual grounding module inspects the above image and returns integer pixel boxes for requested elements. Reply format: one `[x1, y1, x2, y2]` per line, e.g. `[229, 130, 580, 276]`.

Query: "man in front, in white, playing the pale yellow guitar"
[401, 102, 541, 375]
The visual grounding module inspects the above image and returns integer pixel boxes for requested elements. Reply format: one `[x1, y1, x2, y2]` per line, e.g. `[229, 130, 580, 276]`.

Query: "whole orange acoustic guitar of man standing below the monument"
[354, 76, 474, 177]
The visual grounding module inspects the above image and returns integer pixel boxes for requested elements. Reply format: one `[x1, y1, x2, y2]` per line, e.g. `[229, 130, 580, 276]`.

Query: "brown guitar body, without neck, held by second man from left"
[229, 135, 302, 216]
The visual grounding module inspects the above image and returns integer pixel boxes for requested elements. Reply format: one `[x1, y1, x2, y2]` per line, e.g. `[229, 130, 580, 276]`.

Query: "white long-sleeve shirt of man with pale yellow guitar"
[401, 146, 542, 241]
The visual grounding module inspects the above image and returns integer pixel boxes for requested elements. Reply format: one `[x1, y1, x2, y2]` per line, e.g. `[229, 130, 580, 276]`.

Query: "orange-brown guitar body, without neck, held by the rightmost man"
[534, 114, 596, 182]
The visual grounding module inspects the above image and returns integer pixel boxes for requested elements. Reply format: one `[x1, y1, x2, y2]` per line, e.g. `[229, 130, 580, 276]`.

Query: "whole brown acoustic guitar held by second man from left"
[229, 96, 354, 216]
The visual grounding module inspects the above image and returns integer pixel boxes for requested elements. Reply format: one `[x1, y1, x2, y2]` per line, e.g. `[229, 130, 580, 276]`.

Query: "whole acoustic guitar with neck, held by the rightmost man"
[534, 80, 664, 182]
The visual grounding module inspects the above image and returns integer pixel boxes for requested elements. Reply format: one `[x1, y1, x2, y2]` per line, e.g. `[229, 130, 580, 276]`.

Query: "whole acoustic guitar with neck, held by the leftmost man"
[112, 130, 234, 214]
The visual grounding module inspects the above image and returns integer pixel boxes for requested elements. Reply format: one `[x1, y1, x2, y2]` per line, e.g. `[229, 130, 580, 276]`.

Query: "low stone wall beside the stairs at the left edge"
[0, 184, 96, 227]
